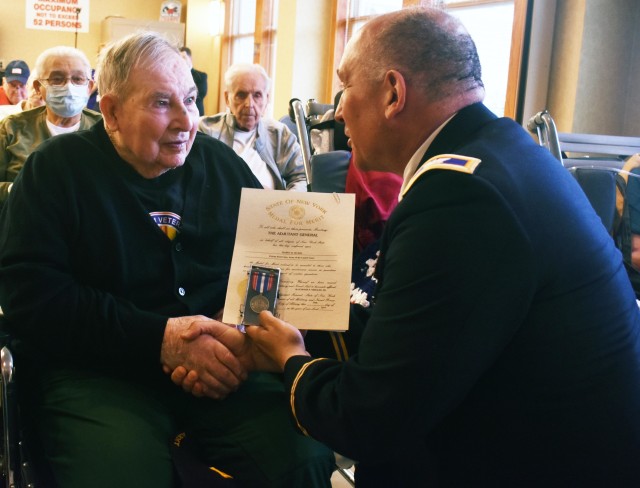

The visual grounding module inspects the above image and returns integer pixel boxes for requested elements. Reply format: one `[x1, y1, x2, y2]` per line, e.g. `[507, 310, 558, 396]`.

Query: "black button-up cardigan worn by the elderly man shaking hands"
[0, 124, 260, 375]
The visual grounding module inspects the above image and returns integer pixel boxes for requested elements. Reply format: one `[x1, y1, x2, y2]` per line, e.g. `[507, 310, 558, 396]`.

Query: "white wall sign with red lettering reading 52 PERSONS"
[26, 0, 89, 32]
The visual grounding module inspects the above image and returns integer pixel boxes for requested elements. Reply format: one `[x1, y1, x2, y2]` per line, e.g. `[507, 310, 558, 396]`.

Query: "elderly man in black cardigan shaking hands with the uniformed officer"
[0, 32, 334, 488]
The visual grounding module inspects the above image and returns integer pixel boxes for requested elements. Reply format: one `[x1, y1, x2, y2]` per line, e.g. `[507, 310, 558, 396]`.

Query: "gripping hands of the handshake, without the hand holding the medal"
[160, 315, 248, 399]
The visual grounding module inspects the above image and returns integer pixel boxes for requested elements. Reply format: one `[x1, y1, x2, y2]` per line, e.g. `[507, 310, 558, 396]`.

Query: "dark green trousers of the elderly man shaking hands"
[23, 369, 334, 488]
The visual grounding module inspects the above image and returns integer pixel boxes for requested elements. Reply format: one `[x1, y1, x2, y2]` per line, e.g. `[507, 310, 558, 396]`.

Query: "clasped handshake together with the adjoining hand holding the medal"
[160, 312, 308, 400]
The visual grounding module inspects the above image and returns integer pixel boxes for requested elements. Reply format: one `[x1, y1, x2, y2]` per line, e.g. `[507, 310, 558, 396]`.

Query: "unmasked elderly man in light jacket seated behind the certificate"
[199, 64, 307, 191]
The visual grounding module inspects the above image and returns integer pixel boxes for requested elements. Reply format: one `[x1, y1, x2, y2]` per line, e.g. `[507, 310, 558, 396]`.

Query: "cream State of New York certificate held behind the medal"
[222, 188, 355, 330]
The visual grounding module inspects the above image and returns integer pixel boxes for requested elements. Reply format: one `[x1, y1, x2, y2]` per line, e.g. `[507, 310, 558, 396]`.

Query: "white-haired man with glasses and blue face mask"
[0, 46, 102, 208]
